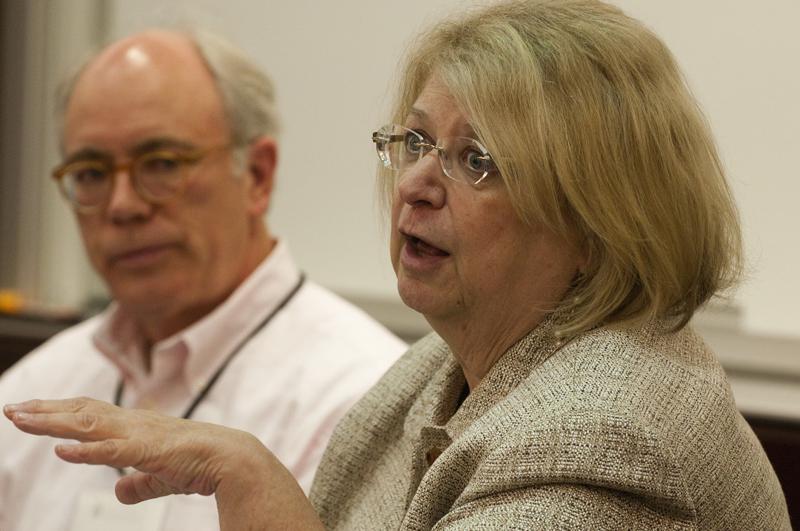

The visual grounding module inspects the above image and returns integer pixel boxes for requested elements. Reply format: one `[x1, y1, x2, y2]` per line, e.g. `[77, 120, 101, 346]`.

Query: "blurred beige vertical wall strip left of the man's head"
[0, 0, 107, 305]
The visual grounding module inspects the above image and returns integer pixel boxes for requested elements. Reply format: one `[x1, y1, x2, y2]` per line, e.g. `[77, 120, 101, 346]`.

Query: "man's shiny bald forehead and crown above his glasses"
[63, 31, 231, 154]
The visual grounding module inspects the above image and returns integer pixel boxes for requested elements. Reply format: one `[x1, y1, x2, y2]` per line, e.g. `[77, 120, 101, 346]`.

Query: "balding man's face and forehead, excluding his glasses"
[63, 34, 266, 339]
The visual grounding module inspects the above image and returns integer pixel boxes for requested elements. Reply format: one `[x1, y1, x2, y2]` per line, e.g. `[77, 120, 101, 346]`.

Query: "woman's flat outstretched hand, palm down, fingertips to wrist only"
[3, 398, 266, 504]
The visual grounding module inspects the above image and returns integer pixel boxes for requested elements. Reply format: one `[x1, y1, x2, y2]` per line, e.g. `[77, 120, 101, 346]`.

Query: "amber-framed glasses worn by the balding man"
[53, 145, 230, 213]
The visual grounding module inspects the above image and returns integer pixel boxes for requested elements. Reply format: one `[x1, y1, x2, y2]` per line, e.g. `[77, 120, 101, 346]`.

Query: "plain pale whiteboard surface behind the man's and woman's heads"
[100, 0, 800, 337]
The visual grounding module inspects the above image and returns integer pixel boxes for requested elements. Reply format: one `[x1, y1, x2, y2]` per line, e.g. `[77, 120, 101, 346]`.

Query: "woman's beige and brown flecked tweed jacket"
[311, 320, 790, 531]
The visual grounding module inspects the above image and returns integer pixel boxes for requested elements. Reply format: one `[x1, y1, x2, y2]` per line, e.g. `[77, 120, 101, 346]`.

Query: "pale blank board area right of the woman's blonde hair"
[617, 0, 800, 338]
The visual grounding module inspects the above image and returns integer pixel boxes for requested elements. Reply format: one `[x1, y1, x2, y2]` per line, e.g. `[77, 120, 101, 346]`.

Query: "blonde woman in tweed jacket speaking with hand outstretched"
[5, 0, 789, 530]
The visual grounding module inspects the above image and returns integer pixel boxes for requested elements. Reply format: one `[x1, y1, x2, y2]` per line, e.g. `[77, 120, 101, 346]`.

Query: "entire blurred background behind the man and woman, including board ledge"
[0, 0, 800, 520]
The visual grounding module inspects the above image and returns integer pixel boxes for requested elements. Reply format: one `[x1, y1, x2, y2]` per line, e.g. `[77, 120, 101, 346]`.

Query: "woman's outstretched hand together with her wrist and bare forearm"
[3, 398, 324, 531]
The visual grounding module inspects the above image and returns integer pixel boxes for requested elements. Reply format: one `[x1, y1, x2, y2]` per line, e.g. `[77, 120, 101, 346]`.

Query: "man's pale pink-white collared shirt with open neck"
[0, 242, 405, 531]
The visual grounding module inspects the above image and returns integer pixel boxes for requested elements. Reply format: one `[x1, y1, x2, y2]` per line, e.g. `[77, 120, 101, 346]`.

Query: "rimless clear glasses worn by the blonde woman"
[372, 124, 498, 186]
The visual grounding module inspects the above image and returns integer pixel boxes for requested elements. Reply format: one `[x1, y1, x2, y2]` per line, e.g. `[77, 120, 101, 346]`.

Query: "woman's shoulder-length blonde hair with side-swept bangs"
[381, 0, 742, 335]
